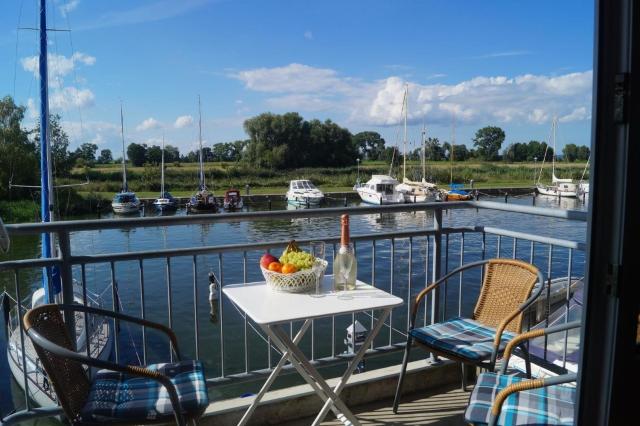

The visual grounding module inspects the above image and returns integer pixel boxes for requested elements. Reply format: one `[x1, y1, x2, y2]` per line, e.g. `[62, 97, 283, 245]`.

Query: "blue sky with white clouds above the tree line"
[0, 0, 594, 157]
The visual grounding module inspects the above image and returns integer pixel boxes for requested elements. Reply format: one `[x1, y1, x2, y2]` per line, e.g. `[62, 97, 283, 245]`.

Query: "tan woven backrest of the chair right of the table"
[473, 259, 544, 333]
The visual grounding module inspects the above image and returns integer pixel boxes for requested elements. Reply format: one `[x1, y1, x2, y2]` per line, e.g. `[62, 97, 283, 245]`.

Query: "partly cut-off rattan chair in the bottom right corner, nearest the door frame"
[464, 321, 580, 426]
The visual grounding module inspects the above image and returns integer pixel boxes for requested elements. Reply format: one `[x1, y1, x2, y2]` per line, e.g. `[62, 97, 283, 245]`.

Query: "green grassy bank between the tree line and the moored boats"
[73, 161, 584, 196]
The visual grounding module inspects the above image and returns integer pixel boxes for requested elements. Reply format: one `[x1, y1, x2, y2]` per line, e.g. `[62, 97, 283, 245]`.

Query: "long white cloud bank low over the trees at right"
[231, 62, 593, 126]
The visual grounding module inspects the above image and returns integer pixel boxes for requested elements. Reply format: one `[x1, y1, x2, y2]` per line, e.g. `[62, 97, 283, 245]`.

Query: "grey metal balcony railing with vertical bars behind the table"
[0, 201, 587, 423]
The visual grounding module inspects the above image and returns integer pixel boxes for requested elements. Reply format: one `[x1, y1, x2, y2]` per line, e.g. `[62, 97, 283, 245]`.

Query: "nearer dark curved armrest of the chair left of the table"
[27, 328, 185, 426]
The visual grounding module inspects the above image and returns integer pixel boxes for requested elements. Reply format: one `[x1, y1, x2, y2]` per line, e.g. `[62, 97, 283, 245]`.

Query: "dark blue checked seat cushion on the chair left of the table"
[80, 361, 209, 422]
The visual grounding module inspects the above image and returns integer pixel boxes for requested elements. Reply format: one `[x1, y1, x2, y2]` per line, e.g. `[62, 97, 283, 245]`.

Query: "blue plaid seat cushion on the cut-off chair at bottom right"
[464, 373, 576, 425]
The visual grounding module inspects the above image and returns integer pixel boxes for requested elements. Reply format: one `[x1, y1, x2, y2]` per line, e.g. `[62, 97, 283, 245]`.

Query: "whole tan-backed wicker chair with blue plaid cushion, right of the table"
[393, 259, 544, 413]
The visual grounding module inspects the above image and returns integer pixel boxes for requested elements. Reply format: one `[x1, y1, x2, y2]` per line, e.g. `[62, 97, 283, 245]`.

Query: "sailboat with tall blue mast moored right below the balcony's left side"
[3, 0, 113, 410]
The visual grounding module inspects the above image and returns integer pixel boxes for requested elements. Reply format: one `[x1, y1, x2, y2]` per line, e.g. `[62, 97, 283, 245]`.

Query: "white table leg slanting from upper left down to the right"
[269, 325, 360, 426]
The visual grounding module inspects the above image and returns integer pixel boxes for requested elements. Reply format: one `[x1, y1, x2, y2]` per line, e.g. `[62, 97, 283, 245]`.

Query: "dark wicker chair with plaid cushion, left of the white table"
[23, 304, 209, 425]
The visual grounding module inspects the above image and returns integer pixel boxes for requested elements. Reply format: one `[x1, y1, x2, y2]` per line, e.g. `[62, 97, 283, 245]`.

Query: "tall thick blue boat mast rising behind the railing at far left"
[39, 0, 61, 302]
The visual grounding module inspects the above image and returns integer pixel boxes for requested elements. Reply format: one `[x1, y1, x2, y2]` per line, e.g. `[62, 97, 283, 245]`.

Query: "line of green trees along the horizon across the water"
[0, 96, 590, 197]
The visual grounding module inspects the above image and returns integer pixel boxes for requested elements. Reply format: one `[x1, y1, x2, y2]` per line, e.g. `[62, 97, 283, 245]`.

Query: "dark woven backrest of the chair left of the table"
[23, 305, 91, 421]
